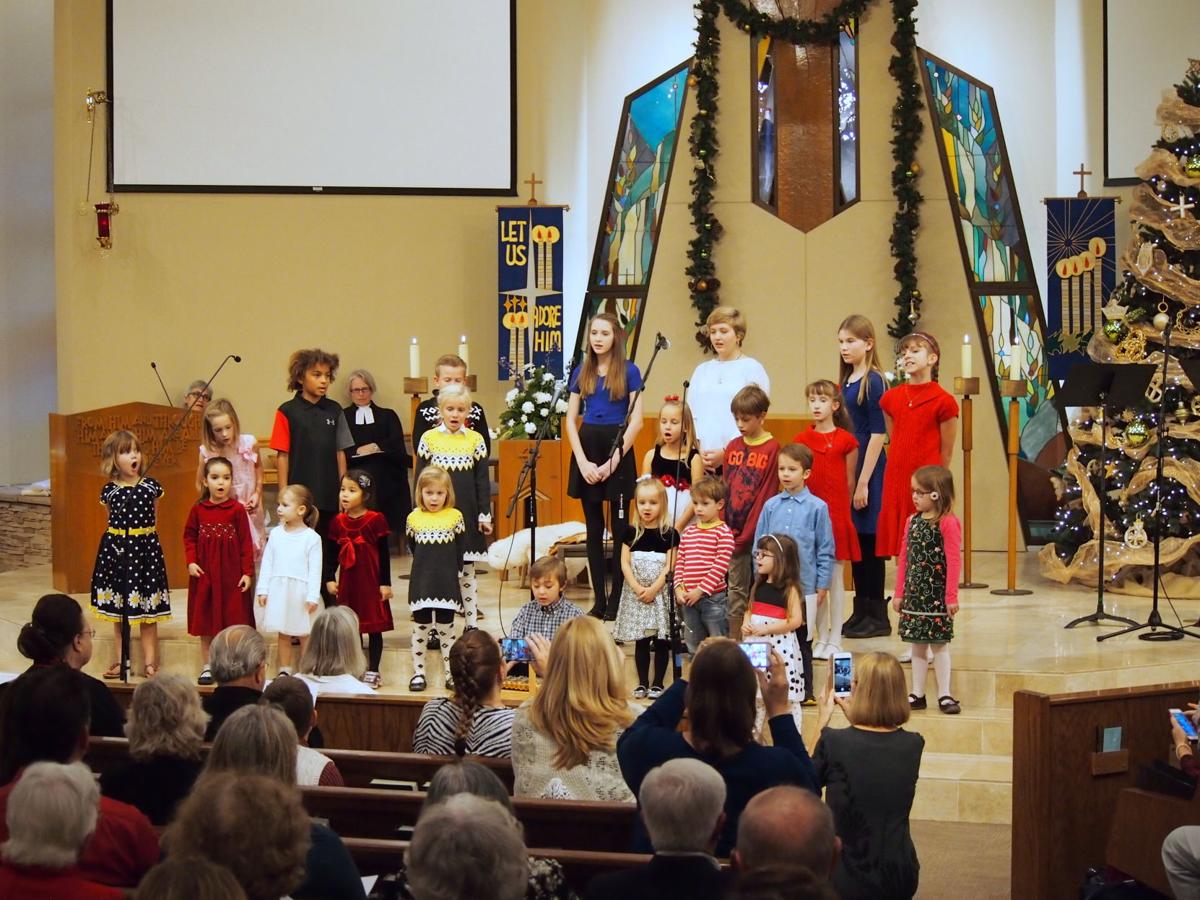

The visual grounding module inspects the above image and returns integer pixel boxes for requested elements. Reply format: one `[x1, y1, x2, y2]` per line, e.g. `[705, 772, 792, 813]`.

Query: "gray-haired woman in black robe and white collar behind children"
[342, 368, 413, 541]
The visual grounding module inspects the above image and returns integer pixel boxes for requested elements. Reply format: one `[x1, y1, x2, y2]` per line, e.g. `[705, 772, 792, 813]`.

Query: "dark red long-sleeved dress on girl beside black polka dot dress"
[184, 498, 254, 637]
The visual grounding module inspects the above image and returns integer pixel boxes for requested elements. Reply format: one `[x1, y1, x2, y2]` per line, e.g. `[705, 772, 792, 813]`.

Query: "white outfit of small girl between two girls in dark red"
[254, 526, 320, 636]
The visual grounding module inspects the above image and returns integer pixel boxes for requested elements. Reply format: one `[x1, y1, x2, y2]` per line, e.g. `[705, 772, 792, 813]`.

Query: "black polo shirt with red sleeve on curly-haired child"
[271, 391, 354, 511]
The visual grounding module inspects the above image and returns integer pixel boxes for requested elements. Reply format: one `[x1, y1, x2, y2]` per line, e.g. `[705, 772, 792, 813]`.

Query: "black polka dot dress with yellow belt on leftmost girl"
[91, 478, 170, 624]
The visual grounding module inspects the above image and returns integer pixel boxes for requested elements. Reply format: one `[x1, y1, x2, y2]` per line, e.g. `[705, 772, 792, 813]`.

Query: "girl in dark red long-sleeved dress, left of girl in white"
[184, 458, 254, 684]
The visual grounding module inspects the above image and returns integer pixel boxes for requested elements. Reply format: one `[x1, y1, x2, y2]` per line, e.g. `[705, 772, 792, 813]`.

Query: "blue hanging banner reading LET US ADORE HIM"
[497, 206, 563, 382]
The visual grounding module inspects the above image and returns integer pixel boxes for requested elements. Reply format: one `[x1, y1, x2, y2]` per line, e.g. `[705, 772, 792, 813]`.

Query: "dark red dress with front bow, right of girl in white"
[329, 510, 395, 635]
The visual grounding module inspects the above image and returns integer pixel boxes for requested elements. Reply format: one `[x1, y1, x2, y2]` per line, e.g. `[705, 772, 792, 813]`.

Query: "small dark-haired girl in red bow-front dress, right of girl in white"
[325, 469, 395, 688]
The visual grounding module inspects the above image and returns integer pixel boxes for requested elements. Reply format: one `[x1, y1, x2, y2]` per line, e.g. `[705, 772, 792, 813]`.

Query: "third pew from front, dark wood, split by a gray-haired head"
[301, 787, 637, 852]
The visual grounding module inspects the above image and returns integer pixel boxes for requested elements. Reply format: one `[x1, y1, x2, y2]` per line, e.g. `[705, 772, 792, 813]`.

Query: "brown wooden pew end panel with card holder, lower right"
[1012, 682, 1200, 900]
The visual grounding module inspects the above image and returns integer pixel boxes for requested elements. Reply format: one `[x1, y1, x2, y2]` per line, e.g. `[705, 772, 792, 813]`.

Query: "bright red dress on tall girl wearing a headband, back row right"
[875, 382, 959, 557]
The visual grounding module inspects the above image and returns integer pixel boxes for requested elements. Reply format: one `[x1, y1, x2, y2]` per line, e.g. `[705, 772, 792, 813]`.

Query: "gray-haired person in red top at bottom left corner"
[0, 762, 125, 900]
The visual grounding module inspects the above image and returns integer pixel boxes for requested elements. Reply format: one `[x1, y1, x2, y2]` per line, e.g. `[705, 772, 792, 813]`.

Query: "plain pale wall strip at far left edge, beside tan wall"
[0, 0, 55, 485]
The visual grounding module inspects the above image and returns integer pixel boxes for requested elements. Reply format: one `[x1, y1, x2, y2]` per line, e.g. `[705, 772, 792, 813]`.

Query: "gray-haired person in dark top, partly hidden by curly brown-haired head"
[206, 704, 365, 900]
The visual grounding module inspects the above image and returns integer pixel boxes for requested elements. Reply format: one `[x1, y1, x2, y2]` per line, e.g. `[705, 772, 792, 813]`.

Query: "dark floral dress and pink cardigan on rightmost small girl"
[896, 514, 961, 643]
